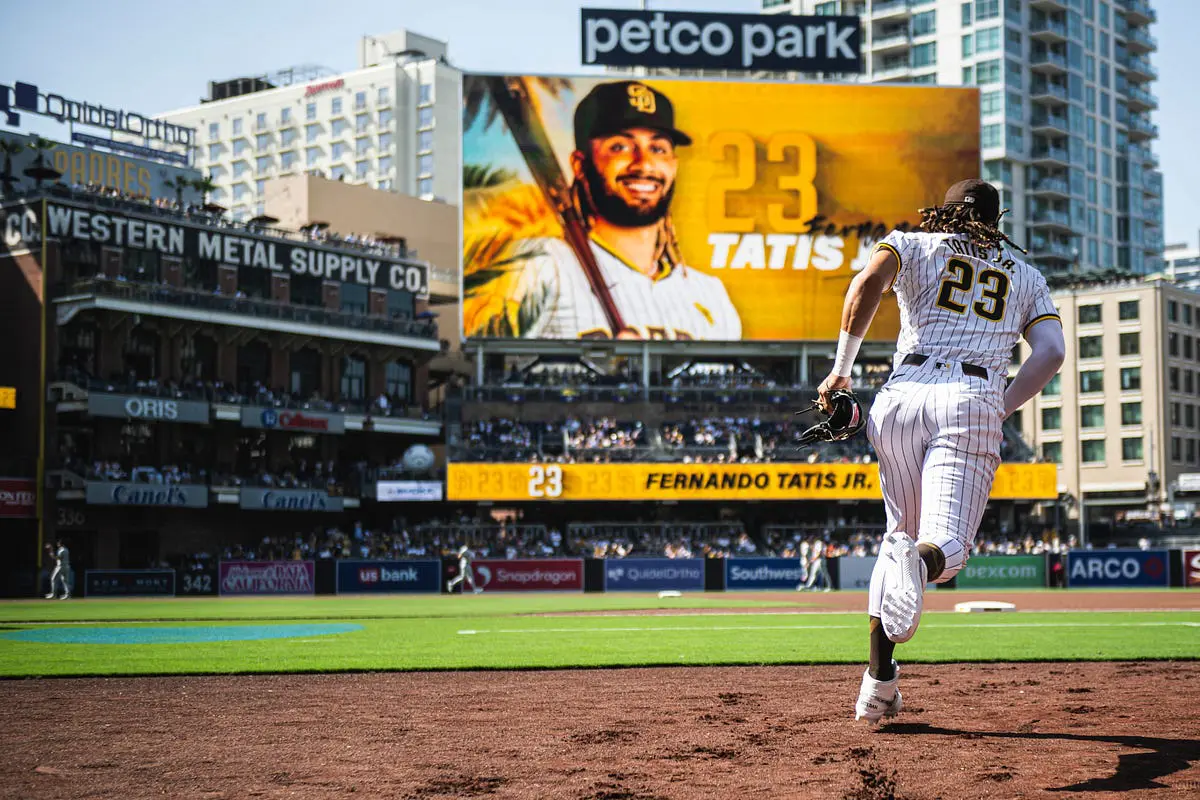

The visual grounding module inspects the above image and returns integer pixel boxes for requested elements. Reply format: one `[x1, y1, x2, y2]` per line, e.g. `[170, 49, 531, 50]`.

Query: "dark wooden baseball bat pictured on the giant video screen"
[485, 76, 625, 337]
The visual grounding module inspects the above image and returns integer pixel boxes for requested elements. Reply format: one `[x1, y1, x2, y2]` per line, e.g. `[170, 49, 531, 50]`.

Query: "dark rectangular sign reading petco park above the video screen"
[580, 8, 863, 72]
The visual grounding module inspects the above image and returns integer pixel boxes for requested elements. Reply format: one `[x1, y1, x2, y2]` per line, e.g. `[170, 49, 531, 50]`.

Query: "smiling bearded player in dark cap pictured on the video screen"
[496, 80, 742, 339]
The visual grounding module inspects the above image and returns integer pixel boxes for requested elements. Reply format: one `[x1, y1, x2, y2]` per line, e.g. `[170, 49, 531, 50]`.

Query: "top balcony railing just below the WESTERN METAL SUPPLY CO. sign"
[56, 276, 438, 339]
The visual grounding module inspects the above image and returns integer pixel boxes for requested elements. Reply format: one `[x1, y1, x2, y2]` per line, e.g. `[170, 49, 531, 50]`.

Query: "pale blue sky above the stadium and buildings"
[0, 0, 1200, 246]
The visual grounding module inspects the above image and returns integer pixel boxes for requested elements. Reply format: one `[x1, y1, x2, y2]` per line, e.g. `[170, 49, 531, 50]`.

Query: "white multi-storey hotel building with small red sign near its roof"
[158, 30, 462, 221]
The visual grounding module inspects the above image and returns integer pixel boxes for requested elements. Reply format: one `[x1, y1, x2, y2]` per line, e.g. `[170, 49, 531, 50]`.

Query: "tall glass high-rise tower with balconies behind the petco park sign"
[762, 0, 1163, 275]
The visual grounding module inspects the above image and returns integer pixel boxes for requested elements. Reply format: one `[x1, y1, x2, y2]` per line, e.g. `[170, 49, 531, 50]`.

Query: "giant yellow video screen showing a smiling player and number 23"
[462, 71, 979, 342]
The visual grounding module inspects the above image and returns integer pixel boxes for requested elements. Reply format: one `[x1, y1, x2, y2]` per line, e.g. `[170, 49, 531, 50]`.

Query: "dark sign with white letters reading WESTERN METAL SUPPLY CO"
[2, 200, 430, 297]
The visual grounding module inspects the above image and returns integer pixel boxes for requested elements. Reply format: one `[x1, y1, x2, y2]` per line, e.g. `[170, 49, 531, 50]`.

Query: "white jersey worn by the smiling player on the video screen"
[510, 236, 742, 341]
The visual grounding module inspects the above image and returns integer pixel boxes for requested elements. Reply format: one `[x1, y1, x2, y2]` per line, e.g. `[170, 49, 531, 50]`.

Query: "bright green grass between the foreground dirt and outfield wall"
[0, 595, 1200, 676]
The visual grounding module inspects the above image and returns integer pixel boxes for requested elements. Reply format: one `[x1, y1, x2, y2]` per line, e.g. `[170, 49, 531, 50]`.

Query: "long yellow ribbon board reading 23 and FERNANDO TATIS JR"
[446, 463, 1058, 501]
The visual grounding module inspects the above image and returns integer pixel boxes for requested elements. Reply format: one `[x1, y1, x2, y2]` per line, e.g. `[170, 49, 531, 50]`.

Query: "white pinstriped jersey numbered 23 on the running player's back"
[876, 230, 1058, 373]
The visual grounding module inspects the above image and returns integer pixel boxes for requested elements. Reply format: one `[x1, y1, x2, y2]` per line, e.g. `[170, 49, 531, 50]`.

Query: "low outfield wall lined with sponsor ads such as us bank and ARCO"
[63, 549, 1200, 597]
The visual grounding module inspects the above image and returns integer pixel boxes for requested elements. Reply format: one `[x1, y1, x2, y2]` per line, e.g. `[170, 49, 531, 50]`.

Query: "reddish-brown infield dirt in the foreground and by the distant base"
[0, 591, 1200, 800]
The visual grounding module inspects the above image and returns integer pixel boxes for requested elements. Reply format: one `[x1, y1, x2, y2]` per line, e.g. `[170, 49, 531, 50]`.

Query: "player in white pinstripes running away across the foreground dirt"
[818, 180, 1064, 723]
